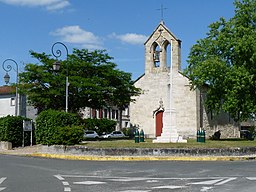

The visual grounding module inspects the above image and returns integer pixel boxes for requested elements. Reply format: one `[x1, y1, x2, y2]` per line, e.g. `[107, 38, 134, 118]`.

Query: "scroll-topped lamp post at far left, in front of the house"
[3, 59, 19, 116]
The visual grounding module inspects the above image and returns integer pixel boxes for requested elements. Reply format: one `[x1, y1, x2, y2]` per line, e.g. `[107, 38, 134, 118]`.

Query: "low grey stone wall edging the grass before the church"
[42, 145, 256, 156]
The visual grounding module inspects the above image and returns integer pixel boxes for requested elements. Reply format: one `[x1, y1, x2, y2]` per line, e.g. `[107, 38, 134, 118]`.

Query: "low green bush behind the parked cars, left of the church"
[84, 119, 116, 135]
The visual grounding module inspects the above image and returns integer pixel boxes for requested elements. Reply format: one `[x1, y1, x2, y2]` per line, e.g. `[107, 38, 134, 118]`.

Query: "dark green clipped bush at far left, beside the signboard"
[0, 115, 33, 147]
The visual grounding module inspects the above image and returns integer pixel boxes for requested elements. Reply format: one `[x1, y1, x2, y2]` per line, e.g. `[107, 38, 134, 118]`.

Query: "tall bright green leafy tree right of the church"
[185, 0, 256, 121]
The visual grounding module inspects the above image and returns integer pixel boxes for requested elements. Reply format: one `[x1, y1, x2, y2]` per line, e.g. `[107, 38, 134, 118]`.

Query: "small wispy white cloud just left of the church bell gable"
[111, 33, 148, 45]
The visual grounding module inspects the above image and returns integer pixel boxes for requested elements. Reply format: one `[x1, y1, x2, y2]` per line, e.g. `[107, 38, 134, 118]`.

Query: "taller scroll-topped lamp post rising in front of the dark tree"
[52, 42, 69, 112]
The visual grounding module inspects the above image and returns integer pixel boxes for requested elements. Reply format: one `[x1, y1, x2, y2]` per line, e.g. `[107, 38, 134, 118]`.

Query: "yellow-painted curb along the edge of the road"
[25, 153, 256, 161]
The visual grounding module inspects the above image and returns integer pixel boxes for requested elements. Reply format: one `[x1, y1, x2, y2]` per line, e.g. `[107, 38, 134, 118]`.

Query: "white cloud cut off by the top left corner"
[0, 0, 70, 10]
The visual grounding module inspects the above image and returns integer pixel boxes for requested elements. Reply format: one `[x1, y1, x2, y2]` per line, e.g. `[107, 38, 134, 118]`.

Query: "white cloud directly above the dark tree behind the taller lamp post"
[51, 25, 102, 49]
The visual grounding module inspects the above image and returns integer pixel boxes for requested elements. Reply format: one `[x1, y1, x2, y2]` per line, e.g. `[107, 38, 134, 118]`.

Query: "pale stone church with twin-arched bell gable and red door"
[129, 21, 239, 142]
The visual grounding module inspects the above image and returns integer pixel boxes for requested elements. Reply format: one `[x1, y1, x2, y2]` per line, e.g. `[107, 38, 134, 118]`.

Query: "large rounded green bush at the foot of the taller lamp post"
[36, 110, 83, 145]
